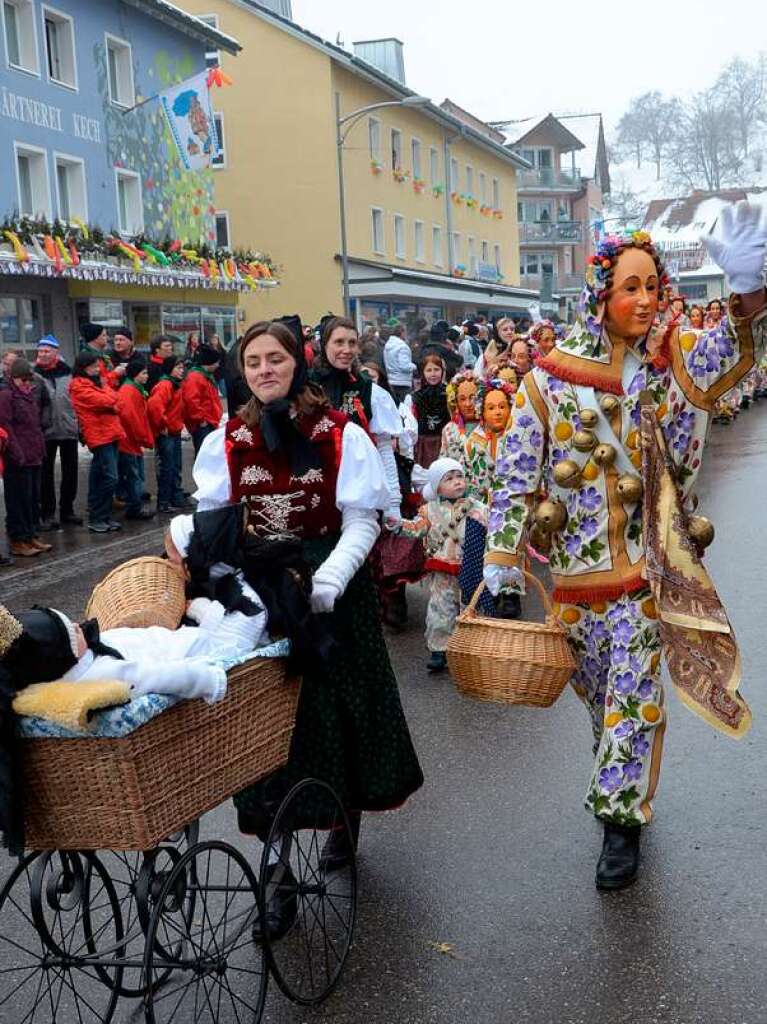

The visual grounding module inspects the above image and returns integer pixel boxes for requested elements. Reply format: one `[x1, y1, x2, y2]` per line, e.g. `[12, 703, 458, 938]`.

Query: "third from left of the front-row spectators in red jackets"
[146, 355, 193, 512]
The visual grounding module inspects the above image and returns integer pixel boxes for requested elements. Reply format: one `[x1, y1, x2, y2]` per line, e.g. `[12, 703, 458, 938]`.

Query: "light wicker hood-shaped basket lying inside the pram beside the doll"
[85, 555, 186, 630]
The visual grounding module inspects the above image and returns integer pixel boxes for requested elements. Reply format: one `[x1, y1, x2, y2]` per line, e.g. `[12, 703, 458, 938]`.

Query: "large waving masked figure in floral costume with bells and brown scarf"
[484, 204, 767, 889]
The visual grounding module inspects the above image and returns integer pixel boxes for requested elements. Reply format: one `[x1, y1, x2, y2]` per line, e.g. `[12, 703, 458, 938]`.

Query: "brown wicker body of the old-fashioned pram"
[22, 658, 300, 850]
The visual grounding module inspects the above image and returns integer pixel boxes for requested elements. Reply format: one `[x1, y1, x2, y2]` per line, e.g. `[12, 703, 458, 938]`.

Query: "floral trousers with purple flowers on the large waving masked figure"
[557, 590, 666, 825]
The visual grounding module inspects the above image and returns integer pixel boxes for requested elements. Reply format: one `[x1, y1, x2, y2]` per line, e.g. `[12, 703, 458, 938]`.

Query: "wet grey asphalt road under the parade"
[0, 403, 767, 1024]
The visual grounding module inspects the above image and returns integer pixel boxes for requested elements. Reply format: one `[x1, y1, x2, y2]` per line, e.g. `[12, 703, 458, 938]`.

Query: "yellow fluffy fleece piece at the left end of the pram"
[13, 679, 130, 730]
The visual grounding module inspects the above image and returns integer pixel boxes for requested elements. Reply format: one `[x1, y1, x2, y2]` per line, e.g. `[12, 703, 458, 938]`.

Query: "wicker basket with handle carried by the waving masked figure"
[448, 572, 576, 708]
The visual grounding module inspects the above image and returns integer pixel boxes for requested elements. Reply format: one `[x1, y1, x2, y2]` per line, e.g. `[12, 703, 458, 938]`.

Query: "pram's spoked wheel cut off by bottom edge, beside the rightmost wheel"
[143, 841, 268, 1024]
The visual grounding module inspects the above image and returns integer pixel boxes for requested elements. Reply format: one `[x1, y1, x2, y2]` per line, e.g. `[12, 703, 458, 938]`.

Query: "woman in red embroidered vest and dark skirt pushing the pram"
[189, 317, 423, 934]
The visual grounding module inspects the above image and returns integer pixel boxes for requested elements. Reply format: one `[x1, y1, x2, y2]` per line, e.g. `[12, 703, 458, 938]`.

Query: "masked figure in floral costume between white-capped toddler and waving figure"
[459, 371, 520, 617]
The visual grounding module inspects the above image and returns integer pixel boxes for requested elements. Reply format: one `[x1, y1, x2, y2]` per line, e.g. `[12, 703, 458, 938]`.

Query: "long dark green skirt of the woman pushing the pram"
[235, 538, 423, 838]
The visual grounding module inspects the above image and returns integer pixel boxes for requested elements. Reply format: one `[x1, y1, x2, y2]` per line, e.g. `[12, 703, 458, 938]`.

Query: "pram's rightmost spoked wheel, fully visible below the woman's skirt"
[260, 779, 356, 1006]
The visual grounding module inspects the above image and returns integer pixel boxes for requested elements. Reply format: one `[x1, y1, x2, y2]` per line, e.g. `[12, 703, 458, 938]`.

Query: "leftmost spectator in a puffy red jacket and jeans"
[70, 352, 125, 534]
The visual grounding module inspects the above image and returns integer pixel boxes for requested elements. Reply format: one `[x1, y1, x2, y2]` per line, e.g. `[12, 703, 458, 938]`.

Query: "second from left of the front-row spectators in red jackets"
[117, 355, 155, 519]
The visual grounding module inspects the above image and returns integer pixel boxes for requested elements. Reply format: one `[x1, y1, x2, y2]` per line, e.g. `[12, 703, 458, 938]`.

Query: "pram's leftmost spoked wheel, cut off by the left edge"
[0, 851, 123, 1024]
